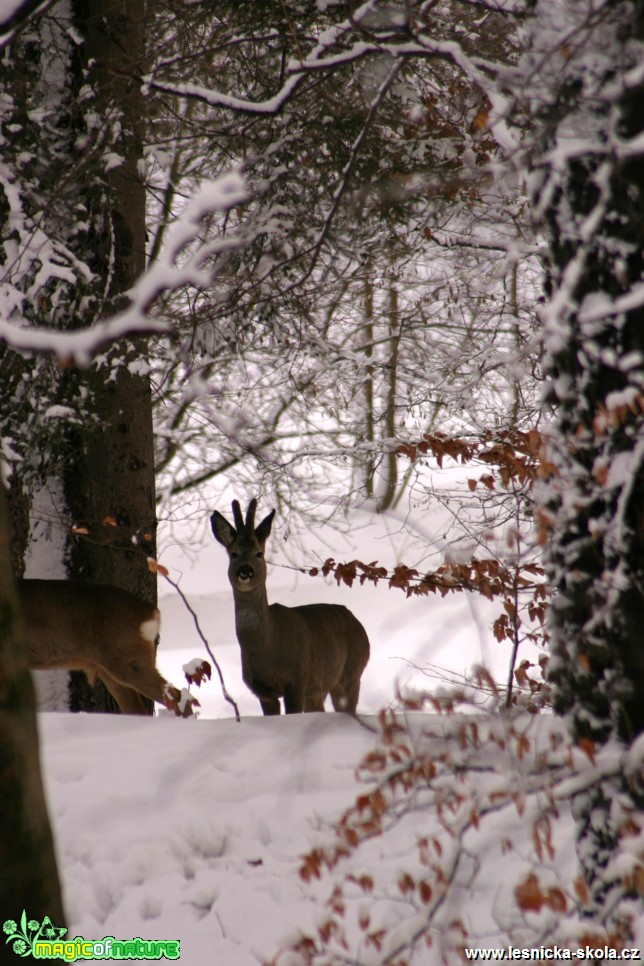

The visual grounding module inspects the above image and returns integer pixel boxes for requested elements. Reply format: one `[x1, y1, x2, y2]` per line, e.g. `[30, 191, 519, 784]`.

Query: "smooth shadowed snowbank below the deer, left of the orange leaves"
[43, 714, 370, 966]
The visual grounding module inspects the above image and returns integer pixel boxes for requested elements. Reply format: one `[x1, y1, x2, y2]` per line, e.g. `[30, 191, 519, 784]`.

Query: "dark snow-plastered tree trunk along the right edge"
[524, 0, 644, 917]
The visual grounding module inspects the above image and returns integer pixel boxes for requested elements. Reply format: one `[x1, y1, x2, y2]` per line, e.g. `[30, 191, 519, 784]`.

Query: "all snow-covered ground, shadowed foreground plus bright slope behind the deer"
[23, 520, 644, 966]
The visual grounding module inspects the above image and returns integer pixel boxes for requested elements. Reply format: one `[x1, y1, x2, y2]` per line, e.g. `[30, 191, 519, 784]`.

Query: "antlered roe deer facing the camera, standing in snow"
[210, 500, 369, 714]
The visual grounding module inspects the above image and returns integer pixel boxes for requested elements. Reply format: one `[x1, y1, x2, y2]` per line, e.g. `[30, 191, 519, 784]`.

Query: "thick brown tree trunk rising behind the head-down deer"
[65, 0, 156, 707]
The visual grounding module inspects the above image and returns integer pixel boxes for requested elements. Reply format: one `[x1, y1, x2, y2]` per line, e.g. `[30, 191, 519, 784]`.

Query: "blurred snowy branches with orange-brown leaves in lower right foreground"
[272, 693, 644, 966]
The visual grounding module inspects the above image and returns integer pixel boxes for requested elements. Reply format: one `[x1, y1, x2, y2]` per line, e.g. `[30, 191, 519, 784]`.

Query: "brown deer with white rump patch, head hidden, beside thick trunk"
[16, 580, 198, 717]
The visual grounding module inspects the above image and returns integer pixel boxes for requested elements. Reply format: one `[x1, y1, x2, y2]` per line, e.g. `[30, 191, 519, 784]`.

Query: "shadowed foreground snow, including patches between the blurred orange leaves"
[36, 696, 644, 966]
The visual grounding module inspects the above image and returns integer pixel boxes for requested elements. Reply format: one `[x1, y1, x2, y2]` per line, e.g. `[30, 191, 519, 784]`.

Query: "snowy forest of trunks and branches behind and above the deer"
[0, 0, 644, 960]
